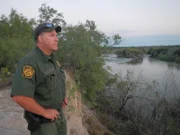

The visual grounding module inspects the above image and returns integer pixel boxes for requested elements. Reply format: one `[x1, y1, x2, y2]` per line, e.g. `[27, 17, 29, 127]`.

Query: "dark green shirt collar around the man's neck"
[35, 46, 54, 61]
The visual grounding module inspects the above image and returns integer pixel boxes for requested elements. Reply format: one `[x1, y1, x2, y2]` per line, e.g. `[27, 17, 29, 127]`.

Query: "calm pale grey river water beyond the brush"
[104, 55, 180, 100]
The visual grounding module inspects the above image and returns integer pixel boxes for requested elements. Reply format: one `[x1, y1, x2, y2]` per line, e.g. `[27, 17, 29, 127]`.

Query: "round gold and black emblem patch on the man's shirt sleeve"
[22, 65, 35, 79]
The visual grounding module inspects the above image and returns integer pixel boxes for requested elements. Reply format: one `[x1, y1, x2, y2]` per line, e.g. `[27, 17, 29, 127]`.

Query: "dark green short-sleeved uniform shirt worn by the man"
[11, 47, 66, 109]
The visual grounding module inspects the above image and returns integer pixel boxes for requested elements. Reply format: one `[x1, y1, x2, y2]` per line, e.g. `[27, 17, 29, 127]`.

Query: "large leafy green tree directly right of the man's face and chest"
[58, 21, 107, 98]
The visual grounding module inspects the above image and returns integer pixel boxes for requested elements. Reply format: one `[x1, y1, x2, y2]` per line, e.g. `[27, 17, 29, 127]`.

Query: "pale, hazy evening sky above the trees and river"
[0, 0, 180, 46]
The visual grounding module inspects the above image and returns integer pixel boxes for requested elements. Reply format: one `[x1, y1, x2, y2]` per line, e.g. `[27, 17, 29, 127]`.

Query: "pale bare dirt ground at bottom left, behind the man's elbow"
[0, 88, 29, 135]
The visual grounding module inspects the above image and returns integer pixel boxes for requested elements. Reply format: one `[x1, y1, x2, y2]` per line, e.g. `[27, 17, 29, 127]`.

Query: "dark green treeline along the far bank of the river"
[107, 45, 180, 63]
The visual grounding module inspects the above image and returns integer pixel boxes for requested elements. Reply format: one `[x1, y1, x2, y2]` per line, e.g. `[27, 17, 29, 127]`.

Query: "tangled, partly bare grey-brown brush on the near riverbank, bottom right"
[96, 71, 180, 135]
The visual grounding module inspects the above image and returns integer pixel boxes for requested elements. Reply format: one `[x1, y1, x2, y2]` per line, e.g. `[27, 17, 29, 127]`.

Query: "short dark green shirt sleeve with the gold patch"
[11, 62, 36, 97]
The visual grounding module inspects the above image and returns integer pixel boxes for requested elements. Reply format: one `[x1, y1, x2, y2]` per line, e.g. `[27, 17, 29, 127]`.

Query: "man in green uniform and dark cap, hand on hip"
[11, 23, 67, 135]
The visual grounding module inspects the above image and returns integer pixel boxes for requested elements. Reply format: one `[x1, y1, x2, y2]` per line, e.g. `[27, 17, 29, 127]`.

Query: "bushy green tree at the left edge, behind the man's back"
[0, 9, 35, 71]
